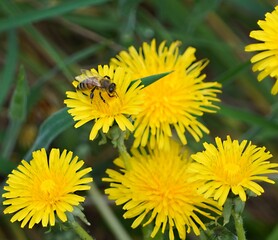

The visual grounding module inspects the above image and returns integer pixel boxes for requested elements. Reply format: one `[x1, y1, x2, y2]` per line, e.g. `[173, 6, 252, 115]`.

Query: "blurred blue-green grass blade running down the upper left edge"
[0, 30, 18, 111]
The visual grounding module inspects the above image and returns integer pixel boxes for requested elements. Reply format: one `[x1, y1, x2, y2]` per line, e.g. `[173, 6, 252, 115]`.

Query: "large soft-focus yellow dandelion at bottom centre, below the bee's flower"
[103, 141, 220, 240]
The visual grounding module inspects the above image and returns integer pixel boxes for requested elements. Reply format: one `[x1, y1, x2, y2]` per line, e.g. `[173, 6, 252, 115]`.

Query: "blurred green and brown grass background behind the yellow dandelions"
[0, 0, 278, 240]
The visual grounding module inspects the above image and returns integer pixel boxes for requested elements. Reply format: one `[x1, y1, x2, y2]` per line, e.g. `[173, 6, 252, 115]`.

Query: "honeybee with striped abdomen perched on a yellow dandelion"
[76, 69, 117, 103]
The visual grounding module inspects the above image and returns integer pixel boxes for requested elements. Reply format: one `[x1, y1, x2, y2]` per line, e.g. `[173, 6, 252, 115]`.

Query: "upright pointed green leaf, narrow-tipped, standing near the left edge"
[9, 66, 28, 122]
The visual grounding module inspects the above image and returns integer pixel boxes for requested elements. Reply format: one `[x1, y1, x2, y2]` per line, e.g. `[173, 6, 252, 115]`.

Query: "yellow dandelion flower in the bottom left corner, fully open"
[2, 148, 93, 228]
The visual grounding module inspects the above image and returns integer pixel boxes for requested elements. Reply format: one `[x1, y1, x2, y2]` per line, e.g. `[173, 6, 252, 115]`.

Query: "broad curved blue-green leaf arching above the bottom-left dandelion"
[24, 108, 74, 161]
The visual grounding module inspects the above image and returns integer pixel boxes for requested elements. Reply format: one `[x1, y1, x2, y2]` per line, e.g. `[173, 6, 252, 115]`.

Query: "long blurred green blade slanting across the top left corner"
[0, 0, 107, 32]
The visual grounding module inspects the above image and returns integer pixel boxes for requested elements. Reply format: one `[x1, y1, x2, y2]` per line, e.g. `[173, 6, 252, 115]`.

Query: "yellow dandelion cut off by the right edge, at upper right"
[245, 6, 278, 95]
